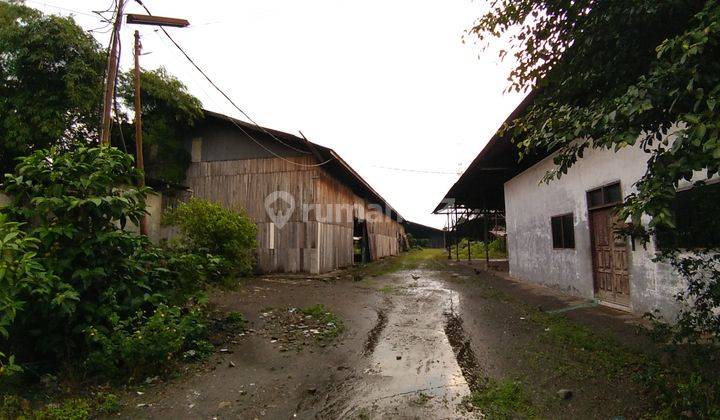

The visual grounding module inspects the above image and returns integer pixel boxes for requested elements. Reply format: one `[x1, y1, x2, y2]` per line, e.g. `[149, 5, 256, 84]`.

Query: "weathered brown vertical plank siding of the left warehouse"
[187, 157, 402, 273]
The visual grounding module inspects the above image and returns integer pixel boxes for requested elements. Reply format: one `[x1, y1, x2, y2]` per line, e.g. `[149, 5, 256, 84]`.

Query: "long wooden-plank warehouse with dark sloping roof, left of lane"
[181, 111, 406, 273]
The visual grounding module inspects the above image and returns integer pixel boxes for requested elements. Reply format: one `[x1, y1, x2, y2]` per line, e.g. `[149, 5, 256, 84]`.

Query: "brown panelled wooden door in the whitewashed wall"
[590, 207, 630, 306]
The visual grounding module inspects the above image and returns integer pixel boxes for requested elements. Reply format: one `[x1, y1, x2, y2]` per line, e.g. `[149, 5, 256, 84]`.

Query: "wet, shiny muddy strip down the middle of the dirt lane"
[322, 271, 477, 418]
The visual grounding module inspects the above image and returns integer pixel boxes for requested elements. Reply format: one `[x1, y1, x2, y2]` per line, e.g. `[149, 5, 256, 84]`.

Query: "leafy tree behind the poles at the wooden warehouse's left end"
[118, 68, 202, 183]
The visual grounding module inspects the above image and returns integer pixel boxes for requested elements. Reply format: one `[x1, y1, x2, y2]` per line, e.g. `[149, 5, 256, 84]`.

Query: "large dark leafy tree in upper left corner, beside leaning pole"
[0, 2, 105, 173]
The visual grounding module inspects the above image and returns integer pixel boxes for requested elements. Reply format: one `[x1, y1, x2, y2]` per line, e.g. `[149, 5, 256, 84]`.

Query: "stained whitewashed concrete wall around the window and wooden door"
[505, 148, 682, 316]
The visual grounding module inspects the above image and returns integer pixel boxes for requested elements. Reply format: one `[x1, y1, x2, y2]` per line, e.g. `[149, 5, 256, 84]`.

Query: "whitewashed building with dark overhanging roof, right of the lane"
[436, 97, 720, 316]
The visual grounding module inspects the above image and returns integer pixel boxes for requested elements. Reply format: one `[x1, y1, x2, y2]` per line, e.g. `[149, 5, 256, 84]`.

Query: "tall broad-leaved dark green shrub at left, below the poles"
[2, 146, 156, 357]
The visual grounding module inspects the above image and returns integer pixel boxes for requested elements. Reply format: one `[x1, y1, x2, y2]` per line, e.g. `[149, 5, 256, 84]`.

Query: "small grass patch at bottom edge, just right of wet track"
[470, 379, 537, 419]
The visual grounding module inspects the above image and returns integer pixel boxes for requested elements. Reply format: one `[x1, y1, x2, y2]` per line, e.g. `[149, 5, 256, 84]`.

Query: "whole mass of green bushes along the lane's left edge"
[0, 146, 221, 375]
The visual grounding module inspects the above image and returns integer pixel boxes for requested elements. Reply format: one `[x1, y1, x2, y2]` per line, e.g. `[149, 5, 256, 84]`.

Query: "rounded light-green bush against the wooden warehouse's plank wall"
[163, 198, 257, 275]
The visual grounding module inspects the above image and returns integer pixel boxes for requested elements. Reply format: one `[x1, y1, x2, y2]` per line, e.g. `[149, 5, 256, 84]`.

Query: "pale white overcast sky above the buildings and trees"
[26, 0, 522, 227]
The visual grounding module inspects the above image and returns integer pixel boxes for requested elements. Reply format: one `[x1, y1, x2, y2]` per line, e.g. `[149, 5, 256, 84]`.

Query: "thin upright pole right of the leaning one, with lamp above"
[127, 14, 190, 235]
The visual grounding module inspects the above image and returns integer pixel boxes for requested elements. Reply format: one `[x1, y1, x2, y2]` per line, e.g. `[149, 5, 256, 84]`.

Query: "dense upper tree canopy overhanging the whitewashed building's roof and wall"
[472, 0, 720, 229]
